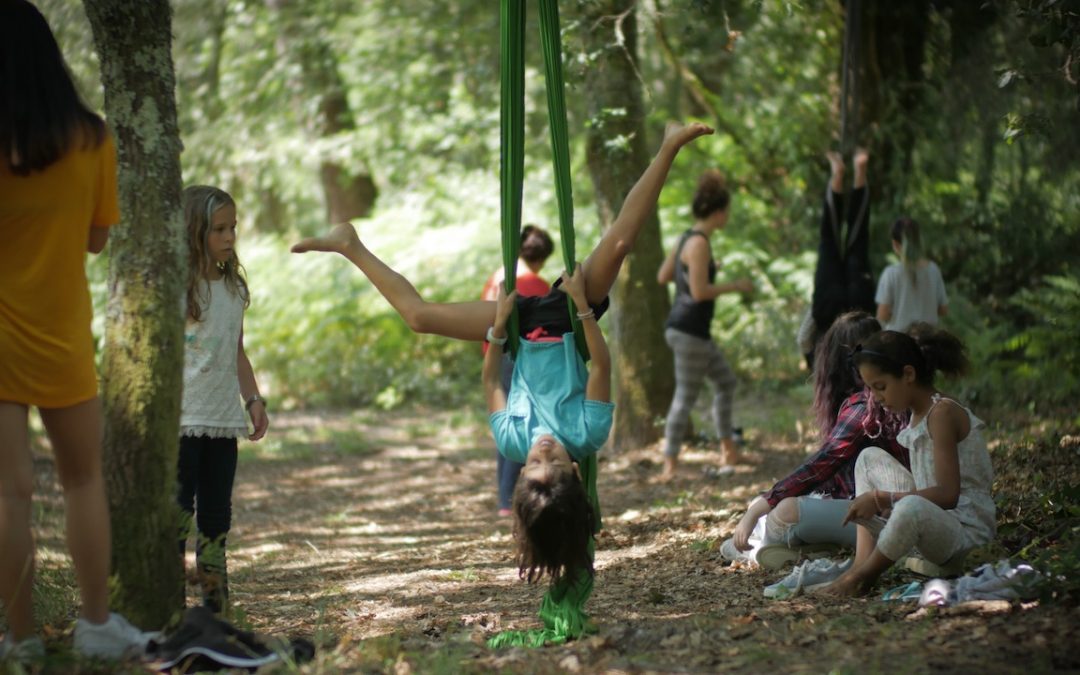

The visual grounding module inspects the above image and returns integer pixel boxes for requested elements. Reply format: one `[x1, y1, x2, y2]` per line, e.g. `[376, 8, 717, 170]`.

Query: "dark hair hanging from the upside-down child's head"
[513, 473, 596, 583]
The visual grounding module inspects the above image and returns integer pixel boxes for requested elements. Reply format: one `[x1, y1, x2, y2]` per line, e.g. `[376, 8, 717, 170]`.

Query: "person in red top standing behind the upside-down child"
[480, 225, 555, 517]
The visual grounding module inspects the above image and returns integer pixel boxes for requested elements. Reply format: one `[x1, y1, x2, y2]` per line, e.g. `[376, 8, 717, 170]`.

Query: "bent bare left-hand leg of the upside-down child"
[292, 222, 495, 340]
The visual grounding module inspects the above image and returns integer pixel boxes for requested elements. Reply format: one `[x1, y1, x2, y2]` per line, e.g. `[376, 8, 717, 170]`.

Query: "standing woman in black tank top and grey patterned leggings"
[657, 170, 754, 481]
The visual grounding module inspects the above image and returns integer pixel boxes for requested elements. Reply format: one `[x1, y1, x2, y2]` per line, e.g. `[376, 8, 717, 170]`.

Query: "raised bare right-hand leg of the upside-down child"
[581, 122, 713, 305]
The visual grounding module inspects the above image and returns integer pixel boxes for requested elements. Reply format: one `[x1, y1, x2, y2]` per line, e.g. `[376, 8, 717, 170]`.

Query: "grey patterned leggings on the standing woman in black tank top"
[664, 328, 735, 457]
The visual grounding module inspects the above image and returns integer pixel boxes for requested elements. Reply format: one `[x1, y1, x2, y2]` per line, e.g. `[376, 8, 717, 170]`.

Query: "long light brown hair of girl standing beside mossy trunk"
[181, 185, 251, 321]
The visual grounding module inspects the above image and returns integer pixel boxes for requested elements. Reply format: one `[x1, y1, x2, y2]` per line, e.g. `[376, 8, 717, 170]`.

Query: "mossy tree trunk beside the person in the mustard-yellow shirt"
[84, 0, 187, 627]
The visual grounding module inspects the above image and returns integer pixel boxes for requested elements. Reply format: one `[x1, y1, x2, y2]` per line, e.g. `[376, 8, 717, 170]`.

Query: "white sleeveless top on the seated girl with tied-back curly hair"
[896, 394, 997, 545]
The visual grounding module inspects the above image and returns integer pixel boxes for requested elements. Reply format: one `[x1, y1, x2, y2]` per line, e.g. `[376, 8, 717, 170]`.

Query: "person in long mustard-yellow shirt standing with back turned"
[0, 0, 149, 661]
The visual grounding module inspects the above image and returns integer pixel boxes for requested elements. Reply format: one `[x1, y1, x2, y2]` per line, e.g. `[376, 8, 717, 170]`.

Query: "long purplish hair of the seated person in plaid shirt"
[813, 311, 903, 437]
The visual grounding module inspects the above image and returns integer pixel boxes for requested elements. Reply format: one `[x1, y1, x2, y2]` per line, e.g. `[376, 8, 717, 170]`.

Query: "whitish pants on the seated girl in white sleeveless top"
[855, 447, 970, 565]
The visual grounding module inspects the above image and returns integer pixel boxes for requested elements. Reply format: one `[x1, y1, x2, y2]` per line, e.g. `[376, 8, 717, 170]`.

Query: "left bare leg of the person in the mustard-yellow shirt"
[0, 402, 33, 640]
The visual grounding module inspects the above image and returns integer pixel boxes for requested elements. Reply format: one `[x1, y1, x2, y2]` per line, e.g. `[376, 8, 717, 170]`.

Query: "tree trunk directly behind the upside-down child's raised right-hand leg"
[573, 0, 675, 450]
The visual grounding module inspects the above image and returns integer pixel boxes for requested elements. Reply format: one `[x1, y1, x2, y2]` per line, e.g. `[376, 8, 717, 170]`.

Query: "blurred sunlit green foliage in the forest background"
[40, 0, 1080, 409]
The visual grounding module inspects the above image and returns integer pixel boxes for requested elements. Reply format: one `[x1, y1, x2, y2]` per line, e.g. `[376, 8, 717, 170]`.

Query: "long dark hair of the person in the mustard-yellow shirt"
[0, 0, 105, 176]
